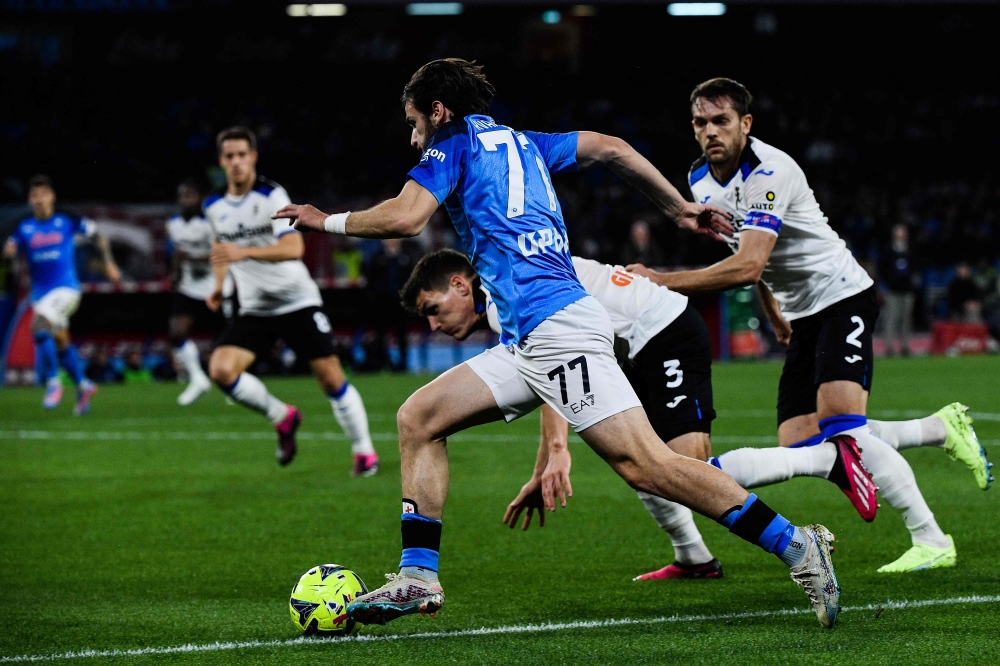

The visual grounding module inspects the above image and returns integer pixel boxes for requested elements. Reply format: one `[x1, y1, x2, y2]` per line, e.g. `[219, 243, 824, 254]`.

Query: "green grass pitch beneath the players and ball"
[0, 357, 1000, 664]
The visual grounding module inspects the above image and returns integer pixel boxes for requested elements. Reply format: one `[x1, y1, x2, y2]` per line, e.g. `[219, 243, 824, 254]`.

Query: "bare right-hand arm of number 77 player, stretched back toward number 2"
[576, 132, 733, 240]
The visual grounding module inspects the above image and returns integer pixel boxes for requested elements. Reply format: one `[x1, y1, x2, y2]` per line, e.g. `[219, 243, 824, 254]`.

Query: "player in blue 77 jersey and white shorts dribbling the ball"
[275, 58, 840, 627]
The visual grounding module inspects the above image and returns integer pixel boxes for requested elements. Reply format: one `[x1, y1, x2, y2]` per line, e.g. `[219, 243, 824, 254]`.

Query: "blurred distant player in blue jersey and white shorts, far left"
[4, 175, 121, 416]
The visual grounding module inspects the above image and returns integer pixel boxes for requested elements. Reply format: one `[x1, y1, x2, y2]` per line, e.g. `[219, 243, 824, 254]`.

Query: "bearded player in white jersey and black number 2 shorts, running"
[629, 78, 991, 573]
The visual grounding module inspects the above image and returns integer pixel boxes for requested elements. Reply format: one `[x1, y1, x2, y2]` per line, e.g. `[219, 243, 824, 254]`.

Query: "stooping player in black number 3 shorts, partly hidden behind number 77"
[400, 250, 876, 580]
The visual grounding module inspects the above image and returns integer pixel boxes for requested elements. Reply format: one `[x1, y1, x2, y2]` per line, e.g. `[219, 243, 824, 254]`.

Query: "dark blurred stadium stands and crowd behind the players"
[0, 0, 1000, 384]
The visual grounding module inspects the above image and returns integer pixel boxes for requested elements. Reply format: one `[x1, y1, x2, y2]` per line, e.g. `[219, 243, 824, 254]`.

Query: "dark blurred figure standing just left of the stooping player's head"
[365, 238, 419, 372]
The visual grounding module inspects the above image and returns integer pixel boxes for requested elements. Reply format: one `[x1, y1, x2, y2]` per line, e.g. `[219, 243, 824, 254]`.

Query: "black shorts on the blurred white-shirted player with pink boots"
[218, 306, 337, 361]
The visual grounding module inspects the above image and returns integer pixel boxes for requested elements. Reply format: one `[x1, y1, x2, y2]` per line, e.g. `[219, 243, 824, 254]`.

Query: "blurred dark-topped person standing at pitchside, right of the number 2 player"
[879, 224, 916, 356]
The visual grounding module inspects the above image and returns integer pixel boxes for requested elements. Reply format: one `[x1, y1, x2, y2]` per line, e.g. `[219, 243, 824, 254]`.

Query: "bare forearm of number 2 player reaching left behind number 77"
[626, 229, 778, 294]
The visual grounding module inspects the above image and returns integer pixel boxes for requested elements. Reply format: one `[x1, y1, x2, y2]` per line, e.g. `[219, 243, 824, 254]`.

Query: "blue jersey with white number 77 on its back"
[409, 115, 587, 344]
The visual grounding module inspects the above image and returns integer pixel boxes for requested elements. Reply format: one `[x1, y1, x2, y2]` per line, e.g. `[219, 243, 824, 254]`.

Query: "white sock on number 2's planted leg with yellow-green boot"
[841, 424, 949, 548]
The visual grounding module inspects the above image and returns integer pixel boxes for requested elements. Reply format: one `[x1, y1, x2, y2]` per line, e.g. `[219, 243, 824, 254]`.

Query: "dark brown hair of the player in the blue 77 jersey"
[400, 58, 496, 119]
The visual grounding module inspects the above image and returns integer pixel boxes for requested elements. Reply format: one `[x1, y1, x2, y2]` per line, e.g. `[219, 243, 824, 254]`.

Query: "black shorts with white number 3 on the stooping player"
[624, 305, 715, 442]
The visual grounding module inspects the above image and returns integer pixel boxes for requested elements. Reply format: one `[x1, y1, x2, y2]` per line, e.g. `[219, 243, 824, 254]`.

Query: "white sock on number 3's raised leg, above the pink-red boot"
[716, 442, 837, 488]
